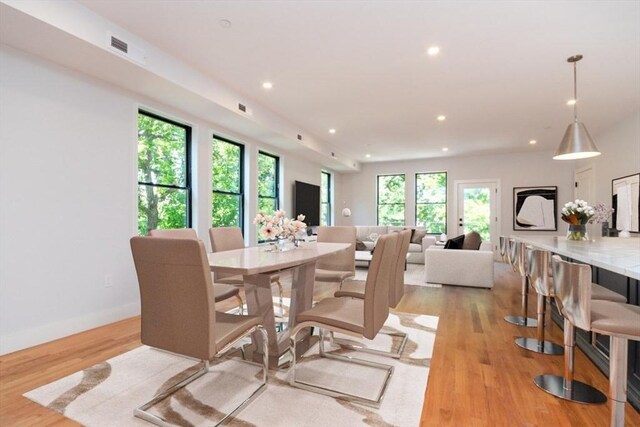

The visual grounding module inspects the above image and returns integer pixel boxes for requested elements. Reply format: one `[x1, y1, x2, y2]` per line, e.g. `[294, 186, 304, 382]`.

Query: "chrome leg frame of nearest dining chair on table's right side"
[289, 325, 394, 408]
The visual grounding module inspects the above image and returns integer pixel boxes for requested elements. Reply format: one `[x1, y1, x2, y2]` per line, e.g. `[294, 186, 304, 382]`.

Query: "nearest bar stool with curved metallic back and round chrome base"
[534, 255, 640, 427]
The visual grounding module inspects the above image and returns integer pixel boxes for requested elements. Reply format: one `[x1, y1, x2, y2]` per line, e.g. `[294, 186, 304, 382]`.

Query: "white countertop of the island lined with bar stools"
[513, 236, 640, 280]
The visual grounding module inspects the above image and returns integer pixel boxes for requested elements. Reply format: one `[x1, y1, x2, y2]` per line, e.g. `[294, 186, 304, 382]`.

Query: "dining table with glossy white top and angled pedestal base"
[208, 242, 349, 368]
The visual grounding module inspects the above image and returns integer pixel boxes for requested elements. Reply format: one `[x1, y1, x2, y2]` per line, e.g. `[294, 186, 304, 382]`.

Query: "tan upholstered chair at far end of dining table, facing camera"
[315, 226, 356, 287]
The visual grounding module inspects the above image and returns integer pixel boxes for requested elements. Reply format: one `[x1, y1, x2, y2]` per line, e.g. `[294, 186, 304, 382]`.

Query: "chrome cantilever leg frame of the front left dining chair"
[133, 325, 269, 427]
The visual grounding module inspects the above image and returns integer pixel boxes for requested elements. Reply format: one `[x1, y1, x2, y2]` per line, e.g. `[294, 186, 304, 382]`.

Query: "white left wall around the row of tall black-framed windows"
[0, 46, 332, 354]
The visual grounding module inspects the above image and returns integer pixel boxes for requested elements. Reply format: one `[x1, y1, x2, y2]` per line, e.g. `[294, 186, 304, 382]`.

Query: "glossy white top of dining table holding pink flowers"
[208, 243, 349, 275]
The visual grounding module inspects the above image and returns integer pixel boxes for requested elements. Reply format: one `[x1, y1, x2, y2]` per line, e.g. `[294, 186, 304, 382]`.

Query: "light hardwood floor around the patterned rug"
[0, 263, 640, 427]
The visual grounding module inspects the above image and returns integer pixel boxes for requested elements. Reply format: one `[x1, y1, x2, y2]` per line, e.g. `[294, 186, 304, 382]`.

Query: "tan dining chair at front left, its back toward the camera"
[130, 237, 269, 426]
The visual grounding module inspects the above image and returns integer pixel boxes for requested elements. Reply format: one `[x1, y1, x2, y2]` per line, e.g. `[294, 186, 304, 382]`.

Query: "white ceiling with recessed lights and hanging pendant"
[79, 0, 640, 162]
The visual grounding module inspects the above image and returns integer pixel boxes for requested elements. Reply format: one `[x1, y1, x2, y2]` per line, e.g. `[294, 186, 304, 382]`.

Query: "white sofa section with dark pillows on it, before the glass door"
[424, 242, 493, 289]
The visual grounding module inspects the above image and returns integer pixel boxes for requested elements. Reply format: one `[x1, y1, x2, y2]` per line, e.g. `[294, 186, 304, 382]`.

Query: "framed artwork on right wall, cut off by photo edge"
[611, 173, 640, 233]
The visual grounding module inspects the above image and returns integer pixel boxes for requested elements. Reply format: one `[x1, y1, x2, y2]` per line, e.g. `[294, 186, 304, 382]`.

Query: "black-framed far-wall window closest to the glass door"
[416, 172, 447, 234]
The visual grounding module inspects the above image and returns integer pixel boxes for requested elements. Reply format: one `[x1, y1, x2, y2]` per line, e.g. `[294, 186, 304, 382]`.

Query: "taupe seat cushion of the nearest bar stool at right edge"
[591, 300, 640, 340]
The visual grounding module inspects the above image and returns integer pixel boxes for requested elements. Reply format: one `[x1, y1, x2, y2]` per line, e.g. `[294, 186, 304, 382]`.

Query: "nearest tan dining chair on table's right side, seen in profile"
[289, 233, 398, 407]
